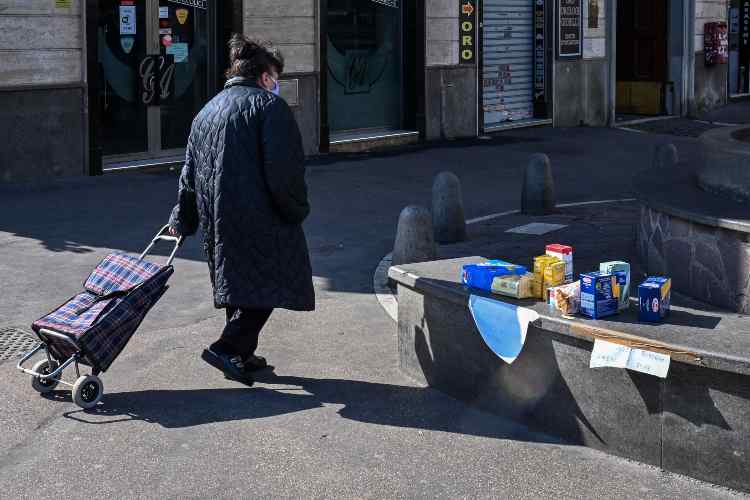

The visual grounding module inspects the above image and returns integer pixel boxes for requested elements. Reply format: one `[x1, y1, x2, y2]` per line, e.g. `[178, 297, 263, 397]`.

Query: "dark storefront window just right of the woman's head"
[327, 0, 403, 132]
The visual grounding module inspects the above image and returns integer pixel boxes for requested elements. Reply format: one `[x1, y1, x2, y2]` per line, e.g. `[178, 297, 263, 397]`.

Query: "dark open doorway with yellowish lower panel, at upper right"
[616, 0, 674, 120]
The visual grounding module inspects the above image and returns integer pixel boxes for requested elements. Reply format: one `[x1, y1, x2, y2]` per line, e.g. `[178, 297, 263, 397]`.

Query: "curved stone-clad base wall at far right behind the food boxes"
[638, 206, 750, 314]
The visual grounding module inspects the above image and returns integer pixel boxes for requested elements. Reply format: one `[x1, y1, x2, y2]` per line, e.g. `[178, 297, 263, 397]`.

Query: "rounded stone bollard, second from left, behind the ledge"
[432, 172, 466, 243]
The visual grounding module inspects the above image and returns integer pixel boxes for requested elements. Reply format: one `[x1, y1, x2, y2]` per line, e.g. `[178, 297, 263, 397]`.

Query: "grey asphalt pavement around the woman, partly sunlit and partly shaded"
[0, 128, 735, 498]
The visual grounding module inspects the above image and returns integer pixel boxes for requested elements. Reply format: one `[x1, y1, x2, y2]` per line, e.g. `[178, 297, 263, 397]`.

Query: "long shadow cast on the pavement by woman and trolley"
[55, 371, 563, 444]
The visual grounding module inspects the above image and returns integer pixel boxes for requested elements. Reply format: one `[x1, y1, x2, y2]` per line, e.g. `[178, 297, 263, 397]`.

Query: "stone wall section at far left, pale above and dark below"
[0, 0, 86, 183]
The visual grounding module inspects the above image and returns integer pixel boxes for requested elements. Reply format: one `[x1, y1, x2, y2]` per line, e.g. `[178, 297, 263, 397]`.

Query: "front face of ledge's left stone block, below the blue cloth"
[398, 285, 661, 465]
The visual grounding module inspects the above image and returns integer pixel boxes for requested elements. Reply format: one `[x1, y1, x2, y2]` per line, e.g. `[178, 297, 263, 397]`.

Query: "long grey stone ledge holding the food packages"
[390, 257, 750, 491]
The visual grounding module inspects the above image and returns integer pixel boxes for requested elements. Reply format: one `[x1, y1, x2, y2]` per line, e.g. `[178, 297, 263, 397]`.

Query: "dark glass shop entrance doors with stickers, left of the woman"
[90, 0, 213, 163]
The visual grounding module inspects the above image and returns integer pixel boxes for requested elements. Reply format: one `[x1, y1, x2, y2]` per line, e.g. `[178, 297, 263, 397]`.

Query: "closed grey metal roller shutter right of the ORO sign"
[482, 0, 534, 128]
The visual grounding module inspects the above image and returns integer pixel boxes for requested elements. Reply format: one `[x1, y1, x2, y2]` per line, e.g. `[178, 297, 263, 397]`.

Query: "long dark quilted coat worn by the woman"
[170, 78, 315, 311]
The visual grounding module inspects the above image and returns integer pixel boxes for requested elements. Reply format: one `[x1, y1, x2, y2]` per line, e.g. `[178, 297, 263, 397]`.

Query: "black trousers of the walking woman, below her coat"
[211, 307, 273, 358]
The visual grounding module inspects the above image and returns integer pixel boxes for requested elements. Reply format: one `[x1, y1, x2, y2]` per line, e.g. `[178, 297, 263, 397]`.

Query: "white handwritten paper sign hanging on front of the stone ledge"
[589, 339, 671, 378]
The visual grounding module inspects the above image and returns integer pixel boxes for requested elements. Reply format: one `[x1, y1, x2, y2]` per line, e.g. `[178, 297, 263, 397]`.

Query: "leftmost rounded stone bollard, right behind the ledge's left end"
[393, 205, 437, 266]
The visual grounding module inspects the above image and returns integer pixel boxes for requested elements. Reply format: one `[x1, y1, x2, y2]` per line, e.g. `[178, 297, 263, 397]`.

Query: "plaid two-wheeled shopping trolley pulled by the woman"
[17, 226, 182, 408]
